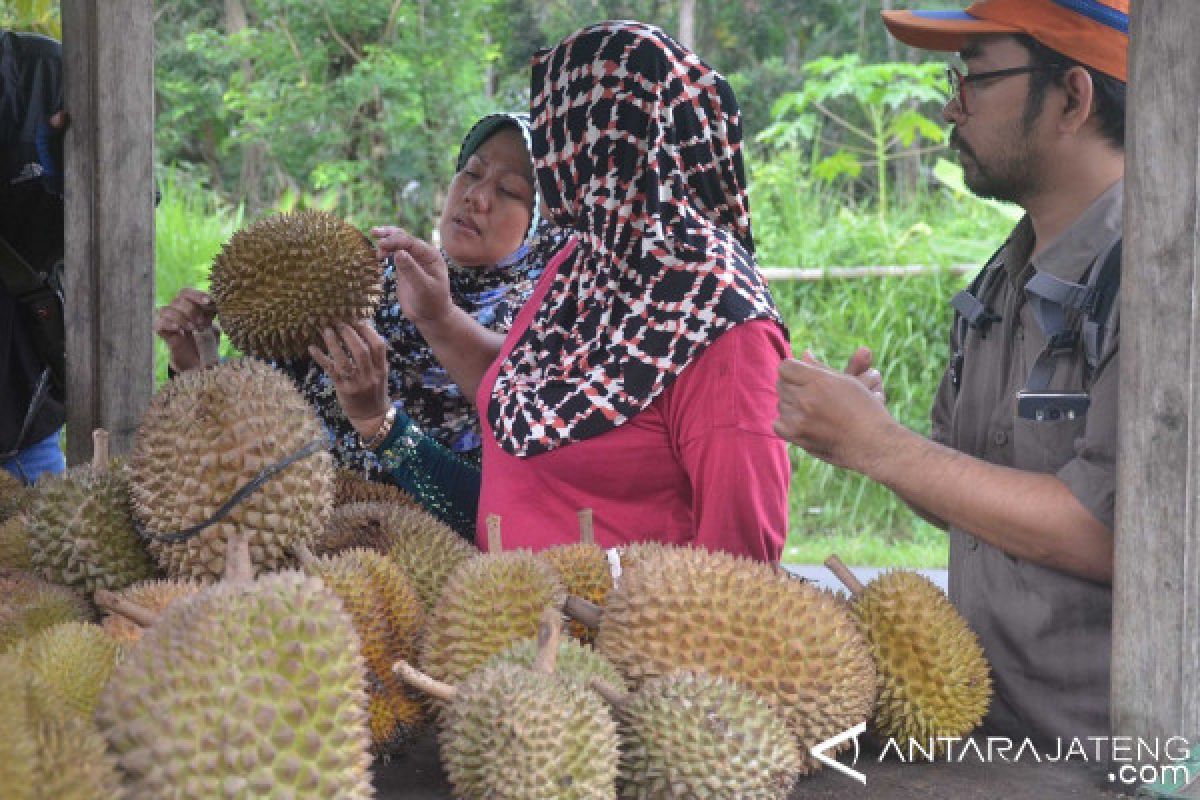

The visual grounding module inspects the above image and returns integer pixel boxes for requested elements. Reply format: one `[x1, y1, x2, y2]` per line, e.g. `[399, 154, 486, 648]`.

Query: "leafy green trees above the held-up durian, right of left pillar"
[156, 0, 500, 231]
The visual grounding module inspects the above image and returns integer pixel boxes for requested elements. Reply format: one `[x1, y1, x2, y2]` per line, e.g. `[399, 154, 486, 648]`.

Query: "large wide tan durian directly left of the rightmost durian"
[596, 548, 875, 774]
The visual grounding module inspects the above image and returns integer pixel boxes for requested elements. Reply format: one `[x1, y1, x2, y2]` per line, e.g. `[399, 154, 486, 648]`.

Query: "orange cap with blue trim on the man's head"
[883, 0, 1129, 80]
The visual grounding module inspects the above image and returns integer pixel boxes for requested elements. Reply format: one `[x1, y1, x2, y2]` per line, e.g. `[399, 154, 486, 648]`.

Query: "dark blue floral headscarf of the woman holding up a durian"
[278, 114, 565, 477]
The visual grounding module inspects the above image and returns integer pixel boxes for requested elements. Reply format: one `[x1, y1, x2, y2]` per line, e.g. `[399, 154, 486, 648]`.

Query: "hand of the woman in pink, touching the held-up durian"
[371, 225, 454, 327]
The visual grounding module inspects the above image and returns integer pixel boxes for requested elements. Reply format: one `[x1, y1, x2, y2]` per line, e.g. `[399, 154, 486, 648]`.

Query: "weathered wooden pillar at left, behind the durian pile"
[62, 0, 155, 463]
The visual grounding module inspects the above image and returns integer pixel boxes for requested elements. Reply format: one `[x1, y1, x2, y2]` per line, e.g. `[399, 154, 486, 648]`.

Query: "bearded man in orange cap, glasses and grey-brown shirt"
[775, 0, 1128, 742]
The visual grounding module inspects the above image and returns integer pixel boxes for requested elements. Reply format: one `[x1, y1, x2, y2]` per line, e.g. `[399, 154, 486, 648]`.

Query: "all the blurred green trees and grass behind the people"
[0, 0, 1014, 566]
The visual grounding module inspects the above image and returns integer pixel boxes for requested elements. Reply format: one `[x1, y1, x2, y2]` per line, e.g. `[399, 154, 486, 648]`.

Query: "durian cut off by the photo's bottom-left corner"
[0, 655, 126, 800]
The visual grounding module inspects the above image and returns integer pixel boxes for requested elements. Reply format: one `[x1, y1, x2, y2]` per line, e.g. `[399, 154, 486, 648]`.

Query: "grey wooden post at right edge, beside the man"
[1112, 0, 1200, 742]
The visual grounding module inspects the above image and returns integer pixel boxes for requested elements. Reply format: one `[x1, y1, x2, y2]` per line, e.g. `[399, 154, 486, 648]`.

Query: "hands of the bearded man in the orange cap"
[774, 348, 902, 475]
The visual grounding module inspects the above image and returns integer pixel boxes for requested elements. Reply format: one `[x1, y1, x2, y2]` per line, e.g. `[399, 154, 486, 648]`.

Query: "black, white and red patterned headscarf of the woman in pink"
[487, 22, 782, 456]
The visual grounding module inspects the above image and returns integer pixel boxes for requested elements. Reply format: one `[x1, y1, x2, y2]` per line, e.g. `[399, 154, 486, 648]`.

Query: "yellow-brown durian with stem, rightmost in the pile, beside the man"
[826, 555, 991, 752]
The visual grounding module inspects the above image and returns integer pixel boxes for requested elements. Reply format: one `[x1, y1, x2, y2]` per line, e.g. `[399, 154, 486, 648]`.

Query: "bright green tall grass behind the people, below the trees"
[156, 158, 1012, 567]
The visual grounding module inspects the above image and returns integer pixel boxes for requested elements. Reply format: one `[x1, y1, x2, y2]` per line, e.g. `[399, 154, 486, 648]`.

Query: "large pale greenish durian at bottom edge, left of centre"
[95, 571, 373, 800]
